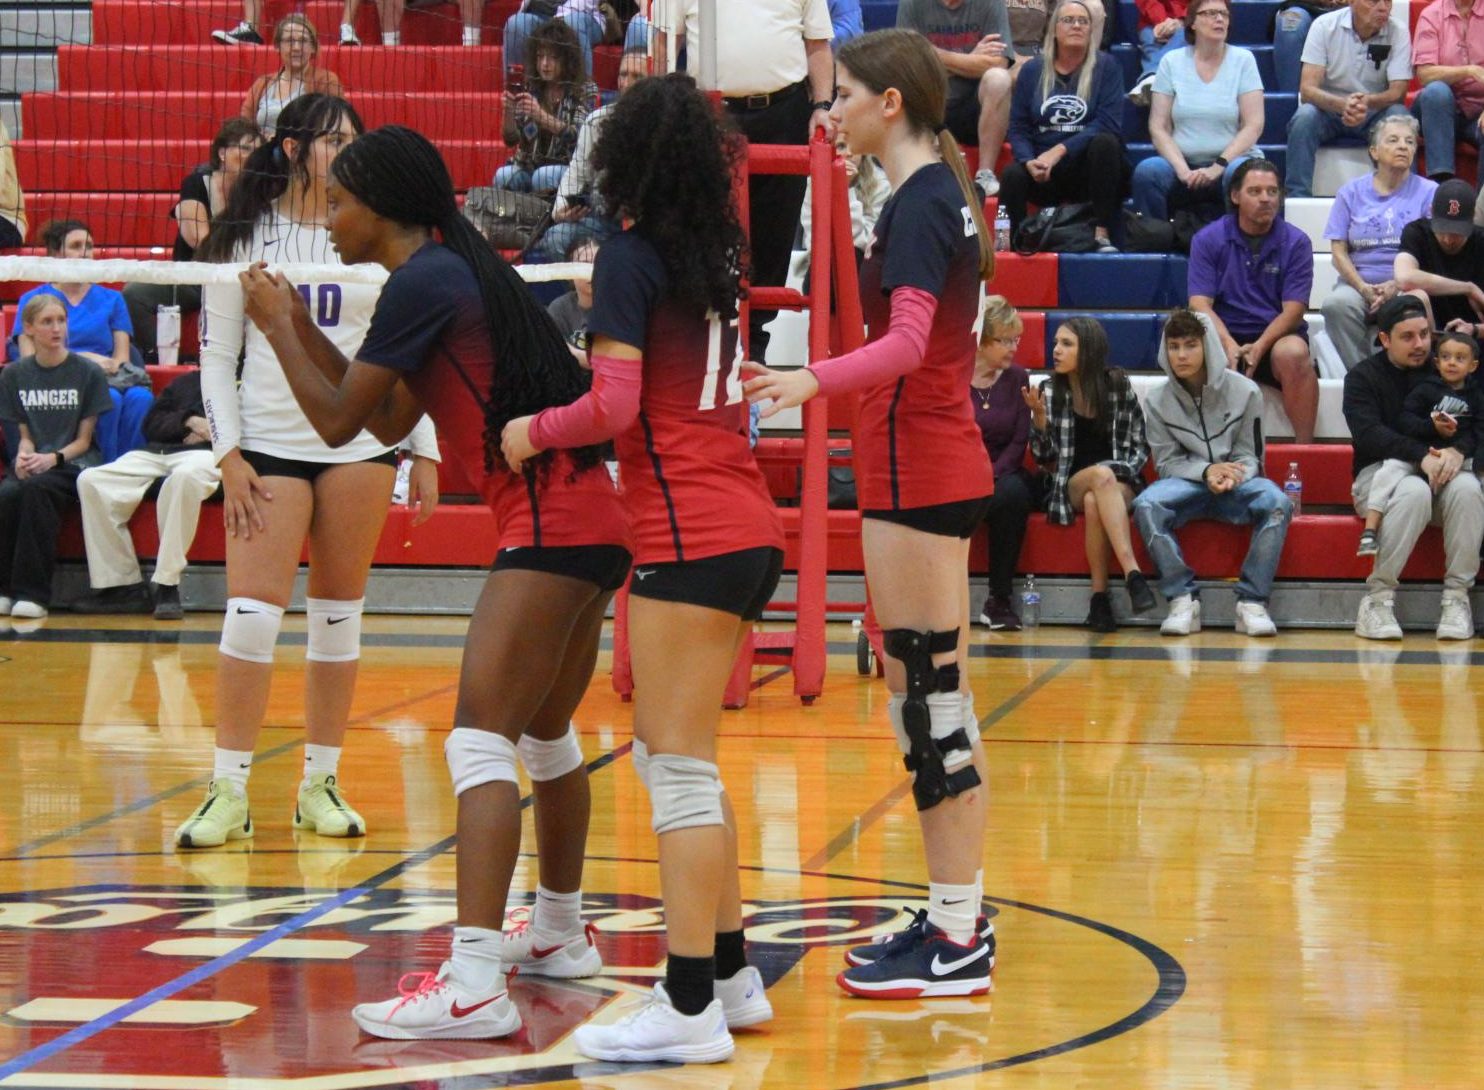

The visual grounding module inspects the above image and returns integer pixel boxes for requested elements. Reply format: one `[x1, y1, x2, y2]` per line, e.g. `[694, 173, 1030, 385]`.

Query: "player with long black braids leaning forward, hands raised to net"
[242, 126, 631, 1038]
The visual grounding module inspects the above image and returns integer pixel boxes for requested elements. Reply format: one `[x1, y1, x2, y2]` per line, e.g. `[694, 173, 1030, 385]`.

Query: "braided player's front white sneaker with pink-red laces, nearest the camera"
[350, 961, 521, 1041]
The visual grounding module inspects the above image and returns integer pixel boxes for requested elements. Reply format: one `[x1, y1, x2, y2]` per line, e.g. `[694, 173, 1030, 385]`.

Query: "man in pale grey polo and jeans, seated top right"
[1285, 0, 1411, 197]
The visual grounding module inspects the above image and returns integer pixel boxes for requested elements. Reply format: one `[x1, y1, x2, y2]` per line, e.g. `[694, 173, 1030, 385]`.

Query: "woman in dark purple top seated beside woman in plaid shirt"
[969, 295, 1034, 632]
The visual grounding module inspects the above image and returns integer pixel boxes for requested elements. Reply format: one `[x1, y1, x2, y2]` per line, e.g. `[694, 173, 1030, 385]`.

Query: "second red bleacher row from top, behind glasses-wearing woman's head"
[56, 43, 505, 98]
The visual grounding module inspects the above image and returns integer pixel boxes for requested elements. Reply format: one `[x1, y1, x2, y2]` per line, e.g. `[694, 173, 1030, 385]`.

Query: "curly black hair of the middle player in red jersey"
[592, 74, 746, 317]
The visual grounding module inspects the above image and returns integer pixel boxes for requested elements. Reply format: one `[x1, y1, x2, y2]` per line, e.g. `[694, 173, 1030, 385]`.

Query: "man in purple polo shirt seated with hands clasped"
[1189, 159, 1319, 443]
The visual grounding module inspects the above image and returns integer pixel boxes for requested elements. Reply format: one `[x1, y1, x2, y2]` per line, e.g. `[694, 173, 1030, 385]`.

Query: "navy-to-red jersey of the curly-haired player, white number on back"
[588, 228, 784, 564]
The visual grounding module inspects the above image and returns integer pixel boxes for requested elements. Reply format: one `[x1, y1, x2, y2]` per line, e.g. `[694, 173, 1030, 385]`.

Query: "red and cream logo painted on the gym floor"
[0, 885, 993, 1090]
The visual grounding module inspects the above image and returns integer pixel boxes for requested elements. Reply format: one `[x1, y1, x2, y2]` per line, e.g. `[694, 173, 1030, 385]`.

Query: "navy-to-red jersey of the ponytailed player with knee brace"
[855, 163, 994, 510]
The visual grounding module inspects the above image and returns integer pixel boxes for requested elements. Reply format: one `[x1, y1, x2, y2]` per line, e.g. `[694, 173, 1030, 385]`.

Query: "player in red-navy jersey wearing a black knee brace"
[745, 30, 994, 998]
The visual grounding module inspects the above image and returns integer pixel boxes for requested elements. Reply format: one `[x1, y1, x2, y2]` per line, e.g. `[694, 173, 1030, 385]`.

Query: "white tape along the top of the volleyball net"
[0, 257, 592, 285]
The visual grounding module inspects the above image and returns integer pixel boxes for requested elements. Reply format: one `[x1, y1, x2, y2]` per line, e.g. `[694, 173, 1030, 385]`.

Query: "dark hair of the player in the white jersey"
[197, 93, 365, 261]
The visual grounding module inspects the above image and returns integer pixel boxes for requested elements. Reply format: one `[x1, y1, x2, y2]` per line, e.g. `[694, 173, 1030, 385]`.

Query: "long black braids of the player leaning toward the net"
[329, 125, 603, 476]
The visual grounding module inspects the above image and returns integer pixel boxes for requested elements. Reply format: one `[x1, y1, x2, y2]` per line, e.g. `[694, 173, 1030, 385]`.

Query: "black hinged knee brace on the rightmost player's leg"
[881, 629, 979, 810]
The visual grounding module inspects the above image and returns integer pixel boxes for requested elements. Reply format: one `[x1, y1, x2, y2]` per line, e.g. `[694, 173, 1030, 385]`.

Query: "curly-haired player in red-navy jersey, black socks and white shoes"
[503, 76, 784, 1062]
